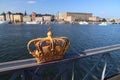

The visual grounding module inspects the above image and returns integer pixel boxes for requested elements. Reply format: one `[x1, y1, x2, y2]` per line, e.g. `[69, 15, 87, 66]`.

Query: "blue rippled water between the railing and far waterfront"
[0, 24, 120, 62]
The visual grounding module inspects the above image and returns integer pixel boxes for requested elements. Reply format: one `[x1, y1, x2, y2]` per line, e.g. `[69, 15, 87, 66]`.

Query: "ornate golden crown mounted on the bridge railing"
[27, 28, 70, 63]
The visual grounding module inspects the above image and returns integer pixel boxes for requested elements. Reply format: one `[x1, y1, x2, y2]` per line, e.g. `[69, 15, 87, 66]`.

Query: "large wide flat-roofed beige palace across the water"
[58, 12, 92, 22]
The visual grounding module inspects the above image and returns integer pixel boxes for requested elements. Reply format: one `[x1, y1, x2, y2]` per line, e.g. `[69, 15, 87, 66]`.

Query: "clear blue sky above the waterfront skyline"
[0, 0, 120, 18]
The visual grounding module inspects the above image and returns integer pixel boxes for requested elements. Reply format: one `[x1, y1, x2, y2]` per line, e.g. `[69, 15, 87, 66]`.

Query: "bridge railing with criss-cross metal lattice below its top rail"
[0, 44, 120, 80]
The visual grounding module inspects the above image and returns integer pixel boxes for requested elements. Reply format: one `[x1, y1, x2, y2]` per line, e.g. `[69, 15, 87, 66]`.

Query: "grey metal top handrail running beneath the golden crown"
[0, 44, 120, 74]
